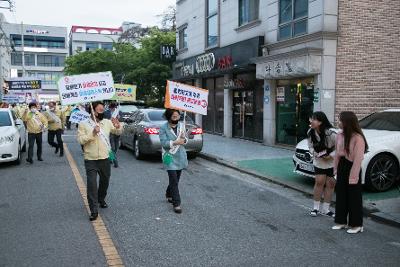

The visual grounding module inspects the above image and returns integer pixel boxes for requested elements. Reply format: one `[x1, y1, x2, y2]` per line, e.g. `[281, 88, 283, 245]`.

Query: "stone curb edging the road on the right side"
[198, 152, 400, 228]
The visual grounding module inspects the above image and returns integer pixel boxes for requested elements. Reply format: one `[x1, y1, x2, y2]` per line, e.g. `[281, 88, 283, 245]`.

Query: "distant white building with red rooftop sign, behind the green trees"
[69, 22, 141, 55]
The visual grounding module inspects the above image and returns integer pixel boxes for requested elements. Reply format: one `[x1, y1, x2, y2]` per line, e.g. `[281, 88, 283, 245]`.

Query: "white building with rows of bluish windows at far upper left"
[3, 23, 68, 95]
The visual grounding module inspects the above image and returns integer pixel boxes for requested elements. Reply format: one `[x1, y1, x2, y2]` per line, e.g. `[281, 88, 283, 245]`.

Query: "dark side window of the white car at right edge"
[360, 112, 400, 131]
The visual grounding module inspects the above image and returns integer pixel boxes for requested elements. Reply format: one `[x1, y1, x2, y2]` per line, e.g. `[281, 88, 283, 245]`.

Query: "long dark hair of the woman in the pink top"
[339, 111, 369, 154]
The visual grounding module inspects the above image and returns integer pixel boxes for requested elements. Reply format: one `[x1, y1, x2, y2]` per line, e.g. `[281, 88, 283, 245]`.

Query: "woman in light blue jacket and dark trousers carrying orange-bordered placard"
[160, 109, 188, 213]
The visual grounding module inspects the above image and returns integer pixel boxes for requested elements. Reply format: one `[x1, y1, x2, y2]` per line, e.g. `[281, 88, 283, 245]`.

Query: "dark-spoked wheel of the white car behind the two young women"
[365, 154, 399, 192]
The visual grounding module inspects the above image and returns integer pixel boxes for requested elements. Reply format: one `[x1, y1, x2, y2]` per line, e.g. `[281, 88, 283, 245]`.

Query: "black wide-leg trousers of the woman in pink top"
[335, 157, 363, 227]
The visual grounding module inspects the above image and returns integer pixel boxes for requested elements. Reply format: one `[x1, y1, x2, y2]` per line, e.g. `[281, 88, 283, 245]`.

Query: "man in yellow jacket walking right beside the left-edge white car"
[22, 102, 47, 164]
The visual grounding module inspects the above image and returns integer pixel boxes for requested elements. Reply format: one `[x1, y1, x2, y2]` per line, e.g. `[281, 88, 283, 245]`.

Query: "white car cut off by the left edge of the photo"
[0, 108, 26, 164]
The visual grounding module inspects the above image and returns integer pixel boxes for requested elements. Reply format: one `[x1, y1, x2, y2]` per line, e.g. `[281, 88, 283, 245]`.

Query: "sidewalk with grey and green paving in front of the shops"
[201, 134, 400, 227]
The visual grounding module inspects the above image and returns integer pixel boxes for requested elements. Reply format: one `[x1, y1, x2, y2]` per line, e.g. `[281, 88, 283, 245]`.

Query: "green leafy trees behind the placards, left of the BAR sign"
[64, 27, 175, 106]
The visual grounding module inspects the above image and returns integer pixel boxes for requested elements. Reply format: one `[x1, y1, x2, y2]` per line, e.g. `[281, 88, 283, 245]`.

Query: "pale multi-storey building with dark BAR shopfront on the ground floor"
[173, 0, 338, 145]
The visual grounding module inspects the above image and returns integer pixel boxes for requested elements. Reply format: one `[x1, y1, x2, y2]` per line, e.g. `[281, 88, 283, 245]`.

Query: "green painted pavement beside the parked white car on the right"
[236, 158, 400, 201]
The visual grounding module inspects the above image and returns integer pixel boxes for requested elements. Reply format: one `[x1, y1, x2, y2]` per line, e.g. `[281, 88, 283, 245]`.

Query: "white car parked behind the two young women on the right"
[293, 109, 400, 192]
